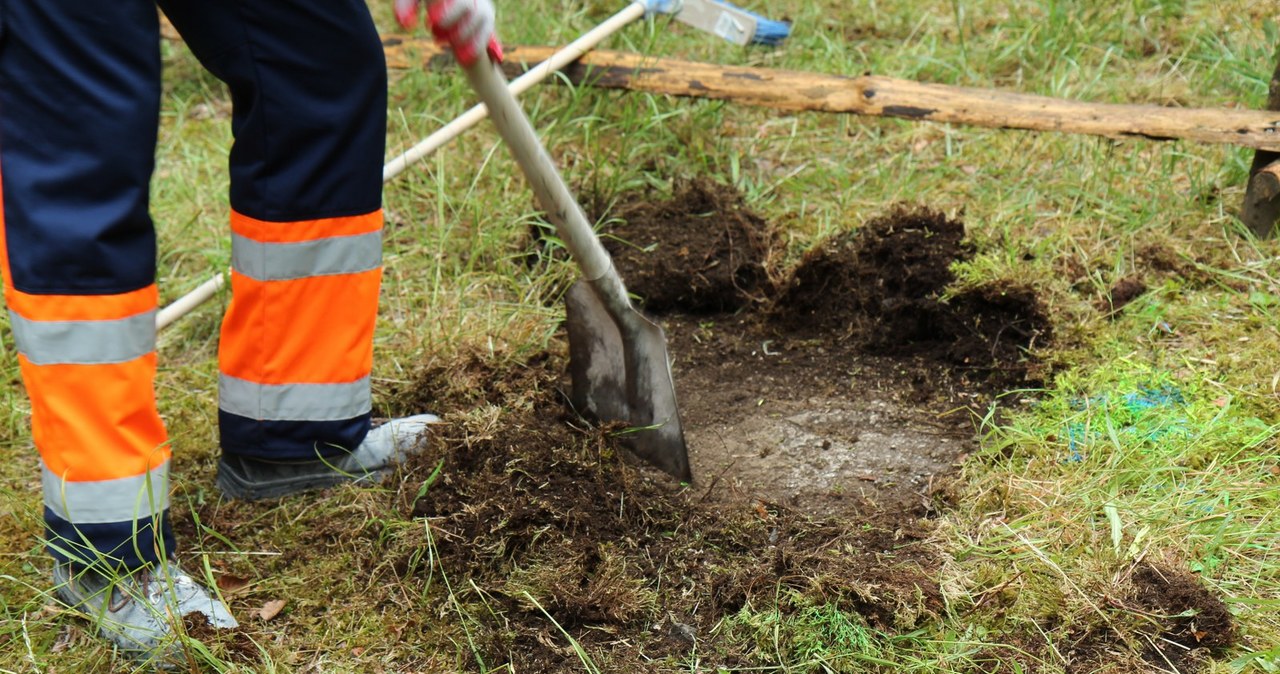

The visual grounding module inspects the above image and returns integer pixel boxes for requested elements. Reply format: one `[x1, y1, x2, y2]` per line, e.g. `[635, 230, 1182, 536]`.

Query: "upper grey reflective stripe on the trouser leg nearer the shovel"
[232, 231, 383, 281]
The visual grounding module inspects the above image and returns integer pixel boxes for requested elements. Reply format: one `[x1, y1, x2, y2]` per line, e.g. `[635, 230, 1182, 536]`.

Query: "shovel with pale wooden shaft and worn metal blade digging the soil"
[463, 56, 692, 481]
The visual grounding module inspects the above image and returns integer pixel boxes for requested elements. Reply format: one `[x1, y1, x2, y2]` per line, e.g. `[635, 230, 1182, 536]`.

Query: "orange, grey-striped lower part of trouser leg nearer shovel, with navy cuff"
[219, 211, 383, 459]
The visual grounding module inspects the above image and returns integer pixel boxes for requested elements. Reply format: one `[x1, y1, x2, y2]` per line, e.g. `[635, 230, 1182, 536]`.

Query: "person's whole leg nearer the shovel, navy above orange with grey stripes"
[160, 0, 432, 498]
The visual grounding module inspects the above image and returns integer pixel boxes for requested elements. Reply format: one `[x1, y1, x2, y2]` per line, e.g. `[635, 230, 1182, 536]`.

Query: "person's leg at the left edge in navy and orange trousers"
[0, 0, 230, 665]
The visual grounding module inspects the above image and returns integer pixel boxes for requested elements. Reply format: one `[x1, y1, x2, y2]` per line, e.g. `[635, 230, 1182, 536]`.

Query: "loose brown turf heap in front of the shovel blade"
[384, 358, 943, 671]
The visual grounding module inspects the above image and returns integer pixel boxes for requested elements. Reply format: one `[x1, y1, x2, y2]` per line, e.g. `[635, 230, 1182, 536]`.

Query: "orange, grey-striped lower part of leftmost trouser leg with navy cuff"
[0, 255, 172, 564]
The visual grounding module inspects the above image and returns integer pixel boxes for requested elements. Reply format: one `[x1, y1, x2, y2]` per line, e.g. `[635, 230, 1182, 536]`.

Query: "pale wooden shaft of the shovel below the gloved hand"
[465, 59, 630, 300]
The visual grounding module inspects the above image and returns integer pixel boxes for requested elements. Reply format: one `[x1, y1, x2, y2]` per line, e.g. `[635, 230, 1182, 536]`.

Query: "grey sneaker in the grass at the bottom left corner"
[54, 561, 239, 669]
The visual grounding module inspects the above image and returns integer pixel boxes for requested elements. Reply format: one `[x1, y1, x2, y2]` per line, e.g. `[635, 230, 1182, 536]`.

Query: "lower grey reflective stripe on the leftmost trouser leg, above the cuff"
[41, 460, 169, 524]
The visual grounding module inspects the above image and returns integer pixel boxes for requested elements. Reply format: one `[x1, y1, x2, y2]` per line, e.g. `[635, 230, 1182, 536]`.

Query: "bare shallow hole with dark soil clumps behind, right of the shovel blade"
[593, 198, 1050, 514]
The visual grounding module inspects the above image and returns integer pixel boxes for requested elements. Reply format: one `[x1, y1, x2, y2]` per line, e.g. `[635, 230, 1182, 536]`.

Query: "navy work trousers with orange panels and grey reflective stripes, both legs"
[0, 0, 387, 568]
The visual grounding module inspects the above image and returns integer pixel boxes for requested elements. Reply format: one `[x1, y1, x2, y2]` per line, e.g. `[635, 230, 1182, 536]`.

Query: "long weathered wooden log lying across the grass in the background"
[384, 38, 1280, 151]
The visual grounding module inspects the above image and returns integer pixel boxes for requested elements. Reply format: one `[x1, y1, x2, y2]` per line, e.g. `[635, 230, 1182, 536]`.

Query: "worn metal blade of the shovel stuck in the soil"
[564, 280, 692, 482]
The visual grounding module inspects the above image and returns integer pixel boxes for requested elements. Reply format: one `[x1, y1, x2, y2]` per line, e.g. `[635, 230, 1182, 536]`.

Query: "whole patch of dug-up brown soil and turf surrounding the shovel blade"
[179, 180, 1235, 673]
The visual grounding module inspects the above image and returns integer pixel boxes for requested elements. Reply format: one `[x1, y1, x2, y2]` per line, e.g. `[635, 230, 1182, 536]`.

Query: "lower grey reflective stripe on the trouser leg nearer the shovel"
[218, 373, 374, 421]
